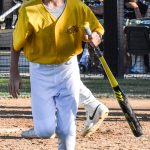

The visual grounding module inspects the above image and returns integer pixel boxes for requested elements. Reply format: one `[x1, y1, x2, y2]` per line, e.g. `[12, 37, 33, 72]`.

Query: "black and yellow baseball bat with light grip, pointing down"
[84, 22, 143, 137]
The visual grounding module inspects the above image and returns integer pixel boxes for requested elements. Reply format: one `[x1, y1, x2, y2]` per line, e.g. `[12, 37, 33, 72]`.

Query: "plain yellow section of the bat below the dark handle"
[99, 56, 118, 87]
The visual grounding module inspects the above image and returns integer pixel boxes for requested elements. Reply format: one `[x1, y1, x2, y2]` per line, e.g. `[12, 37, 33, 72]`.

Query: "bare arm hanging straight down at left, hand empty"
[8, 47, 21, 98]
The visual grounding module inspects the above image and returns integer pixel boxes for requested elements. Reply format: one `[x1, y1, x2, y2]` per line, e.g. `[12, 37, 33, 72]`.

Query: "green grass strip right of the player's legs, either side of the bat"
[82, 78, 150, 97]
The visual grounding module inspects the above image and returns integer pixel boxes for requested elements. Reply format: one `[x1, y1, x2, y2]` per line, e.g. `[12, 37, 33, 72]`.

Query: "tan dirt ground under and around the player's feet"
[0, 98, 150, 150]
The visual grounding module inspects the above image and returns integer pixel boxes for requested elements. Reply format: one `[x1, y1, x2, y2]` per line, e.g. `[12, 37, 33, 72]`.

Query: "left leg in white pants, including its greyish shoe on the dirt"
[22, 63, 57, 138]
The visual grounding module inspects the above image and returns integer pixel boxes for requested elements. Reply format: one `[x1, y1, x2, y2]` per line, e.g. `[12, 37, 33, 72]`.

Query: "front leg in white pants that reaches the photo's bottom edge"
[55, 58, 80, 150]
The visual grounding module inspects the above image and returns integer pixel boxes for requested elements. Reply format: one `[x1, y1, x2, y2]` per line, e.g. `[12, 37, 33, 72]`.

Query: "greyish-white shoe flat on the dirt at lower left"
[21, 128, 56, 139]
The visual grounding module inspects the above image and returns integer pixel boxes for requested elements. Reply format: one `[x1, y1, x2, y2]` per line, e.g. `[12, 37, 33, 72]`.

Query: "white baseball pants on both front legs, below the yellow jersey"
[30, 57, 80, 150]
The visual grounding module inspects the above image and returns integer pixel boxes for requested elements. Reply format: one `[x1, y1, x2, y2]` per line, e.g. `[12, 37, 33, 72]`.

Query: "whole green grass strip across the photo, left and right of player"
[0, 78, 150, 97]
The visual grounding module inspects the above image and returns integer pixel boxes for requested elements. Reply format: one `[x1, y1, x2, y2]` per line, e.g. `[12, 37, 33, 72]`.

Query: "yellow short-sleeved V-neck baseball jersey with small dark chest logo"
[13, 0, 104, 64]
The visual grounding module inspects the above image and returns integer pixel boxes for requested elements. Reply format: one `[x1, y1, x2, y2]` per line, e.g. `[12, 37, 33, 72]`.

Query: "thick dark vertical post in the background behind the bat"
[104, 0, 124, 77]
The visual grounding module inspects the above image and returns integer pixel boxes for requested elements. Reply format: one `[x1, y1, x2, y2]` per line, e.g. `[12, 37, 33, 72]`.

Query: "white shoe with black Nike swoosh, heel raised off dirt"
[82, 104, 109, 137]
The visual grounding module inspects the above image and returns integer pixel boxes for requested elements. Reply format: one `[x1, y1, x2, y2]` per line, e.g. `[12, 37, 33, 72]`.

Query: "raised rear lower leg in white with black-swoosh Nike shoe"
[79, 81, 109, 136]
